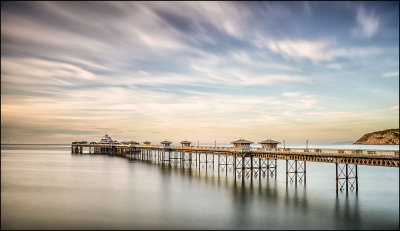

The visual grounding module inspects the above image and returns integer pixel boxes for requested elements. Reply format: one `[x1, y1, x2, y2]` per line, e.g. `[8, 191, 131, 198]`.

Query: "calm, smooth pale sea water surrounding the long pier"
[1, 145, 399, 229]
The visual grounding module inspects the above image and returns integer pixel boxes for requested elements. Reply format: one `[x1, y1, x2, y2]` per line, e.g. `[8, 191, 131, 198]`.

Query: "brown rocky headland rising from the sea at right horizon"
[355, 129, 399, 144]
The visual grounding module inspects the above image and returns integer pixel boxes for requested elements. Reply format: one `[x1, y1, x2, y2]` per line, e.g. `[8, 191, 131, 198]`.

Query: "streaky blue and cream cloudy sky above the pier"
[1, 1, 399, 144]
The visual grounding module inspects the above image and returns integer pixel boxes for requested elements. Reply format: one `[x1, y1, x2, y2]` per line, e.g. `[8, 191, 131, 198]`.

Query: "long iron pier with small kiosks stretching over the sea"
[71, 139, 399, 191]
